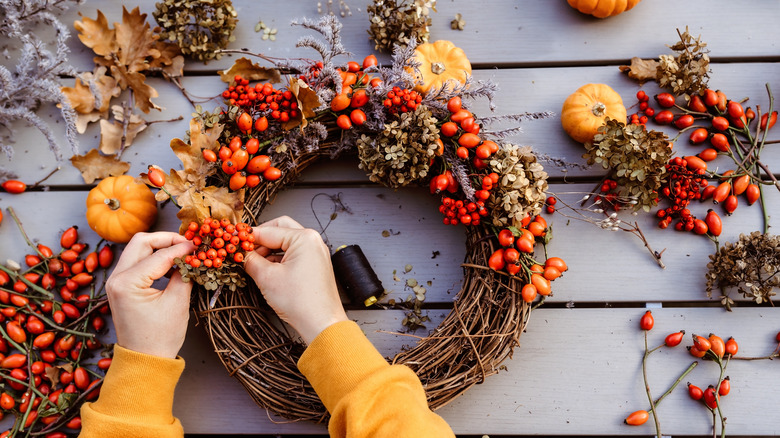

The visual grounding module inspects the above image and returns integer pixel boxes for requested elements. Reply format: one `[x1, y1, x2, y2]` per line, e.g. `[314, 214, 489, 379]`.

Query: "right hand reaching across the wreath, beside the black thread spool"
[244, 216, 347, 344]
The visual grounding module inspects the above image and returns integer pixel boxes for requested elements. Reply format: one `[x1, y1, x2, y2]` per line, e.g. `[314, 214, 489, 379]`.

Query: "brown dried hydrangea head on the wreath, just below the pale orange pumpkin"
[357, 105, 439, 188]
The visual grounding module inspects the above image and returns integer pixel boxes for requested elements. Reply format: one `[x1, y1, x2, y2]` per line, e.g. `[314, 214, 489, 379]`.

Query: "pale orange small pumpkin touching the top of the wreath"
[414, 40, 471, 94]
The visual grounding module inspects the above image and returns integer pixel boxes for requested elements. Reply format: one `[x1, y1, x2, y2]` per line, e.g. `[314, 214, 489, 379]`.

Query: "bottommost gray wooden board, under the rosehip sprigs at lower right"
[174, 307, 780, 436]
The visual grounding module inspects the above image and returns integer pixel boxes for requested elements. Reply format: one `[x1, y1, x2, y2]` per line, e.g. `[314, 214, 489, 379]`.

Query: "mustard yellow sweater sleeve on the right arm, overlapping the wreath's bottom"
[298, 321, 455, 438]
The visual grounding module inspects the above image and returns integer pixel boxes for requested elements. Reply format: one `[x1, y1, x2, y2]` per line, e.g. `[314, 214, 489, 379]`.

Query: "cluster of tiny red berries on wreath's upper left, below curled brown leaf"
[222, 75, 299, 122]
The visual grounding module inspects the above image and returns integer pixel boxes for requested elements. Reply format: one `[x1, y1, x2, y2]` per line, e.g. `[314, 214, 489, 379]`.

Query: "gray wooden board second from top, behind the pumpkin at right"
[0, 63, 780, 185]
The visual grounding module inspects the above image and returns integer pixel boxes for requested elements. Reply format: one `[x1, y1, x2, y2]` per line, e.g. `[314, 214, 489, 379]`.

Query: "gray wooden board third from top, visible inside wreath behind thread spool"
[0, 184, 780, 304]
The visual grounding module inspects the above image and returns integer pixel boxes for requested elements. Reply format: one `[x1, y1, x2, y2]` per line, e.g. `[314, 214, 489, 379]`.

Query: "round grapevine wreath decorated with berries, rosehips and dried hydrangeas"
[145, 16, 566, 421]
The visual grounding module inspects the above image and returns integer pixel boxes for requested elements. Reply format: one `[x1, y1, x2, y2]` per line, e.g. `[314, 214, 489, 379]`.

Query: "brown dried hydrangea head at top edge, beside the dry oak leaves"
[152, 0, 238, 62]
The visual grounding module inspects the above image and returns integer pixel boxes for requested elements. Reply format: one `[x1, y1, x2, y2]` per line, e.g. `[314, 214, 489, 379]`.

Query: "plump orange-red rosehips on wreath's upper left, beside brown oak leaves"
[203, 127, 282, 191]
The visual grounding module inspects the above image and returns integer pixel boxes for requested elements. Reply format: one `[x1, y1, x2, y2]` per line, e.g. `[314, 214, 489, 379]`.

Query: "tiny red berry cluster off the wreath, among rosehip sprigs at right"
[656, 157, 709, 234]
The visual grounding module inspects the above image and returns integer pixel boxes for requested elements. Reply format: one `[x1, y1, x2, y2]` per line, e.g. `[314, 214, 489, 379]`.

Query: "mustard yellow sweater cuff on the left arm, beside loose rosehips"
[79, 345, 184, 438]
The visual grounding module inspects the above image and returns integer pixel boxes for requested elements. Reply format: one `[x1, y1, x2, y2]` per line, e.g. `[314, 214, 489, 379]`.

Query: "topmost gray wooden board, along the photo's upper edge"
[58, 0, 780, 71]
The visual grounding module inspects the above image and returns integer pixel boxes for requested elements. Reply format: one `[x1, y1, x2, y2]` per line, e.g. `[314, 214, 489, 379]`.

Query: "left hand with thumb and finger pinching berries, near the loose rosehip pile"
[106, 232, 195, 358]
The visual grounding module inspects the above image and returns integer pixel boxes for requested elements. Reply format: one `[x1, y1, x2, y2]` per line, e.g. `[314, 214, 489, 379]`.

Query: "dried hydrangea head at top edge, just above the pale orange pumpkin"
[366, 0, 436, 52]
